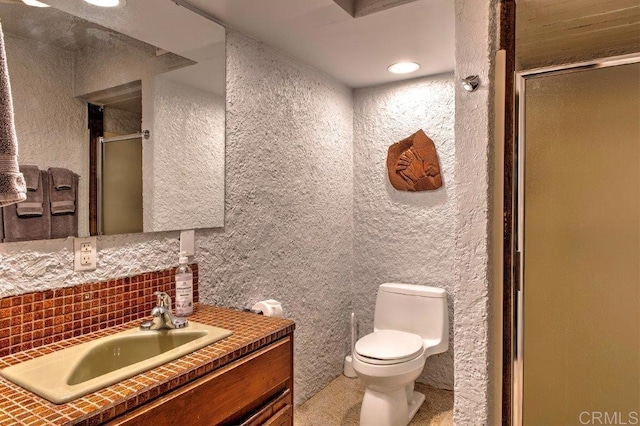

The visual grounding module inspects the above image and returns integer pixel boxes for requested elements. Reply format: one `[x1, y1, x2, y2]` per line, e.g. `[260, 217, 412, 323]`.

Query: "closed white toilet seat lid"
[354, 330, 424, 365]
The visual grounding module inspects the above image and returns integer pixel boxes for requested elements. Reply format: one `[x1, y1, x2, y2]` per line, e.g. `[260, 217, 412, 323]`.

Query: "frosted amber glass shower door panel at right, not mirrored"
[519, 63, 640, 426]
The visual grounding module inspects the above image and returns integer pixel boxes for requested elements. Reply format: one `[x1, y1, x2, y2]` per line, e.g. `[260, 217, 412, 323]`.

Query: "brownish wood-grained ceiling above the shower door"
[516, 0, 640, 69]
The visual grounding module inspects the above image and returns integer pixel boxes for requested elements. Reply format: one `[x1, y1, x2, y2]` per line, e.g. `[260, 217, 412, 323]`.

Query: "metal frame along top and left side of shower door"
[511, 53, 640, 426]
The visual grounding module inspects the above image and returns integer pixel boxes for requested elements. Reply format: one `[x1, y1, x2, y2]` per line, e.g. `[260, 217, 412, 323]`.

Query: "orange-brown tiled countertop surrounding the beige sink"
[0, 304, 295, 425]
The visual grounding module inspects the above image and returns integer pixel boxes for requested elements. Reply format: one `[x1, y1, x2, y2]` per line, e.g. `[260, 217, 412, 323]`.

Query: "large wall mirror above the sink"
[0, 0, 225, 241]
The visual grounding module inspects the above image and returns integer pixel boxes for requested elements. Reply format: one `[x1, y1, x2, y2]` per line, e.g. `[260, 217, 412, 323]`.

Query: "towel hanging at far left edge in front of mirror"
[0, 25, 27, 206]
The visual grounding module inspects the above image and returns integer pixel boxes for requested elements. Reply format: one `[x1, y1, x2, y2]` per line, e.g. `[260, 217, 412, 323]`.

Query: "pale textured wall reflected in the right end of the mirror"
[144, 79, 225, 231]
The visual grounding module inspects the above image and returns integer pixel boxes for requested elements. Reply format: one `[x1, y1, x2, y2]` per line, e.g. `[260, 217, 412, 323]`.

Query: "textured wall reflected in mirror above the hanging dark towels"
[5, 34, 89, 233]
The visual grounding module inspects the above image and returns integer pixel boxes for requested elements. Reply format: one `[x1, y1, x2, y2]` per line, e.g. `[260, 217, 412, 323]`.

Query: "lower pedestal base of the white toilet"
[360, 383, 425, 426]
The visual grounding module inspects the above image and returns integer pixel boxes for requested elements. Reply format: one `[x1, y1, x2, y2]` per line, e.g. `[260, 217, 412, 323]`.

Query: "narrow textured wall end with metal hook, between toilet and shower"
[453, 0, 500, 425]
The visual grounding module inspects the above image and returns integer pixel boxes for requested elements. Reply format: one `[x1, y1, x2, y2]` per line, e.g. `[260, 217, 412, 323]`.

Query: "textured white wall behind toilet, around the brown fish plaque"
[352, 74, 458, 389]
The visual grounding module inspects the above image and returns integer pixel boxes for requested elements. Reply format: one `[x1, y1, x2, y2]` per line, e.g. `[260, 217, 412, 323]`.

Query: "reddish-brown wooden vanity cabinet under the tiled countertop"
[108, 335, 293, 426]
